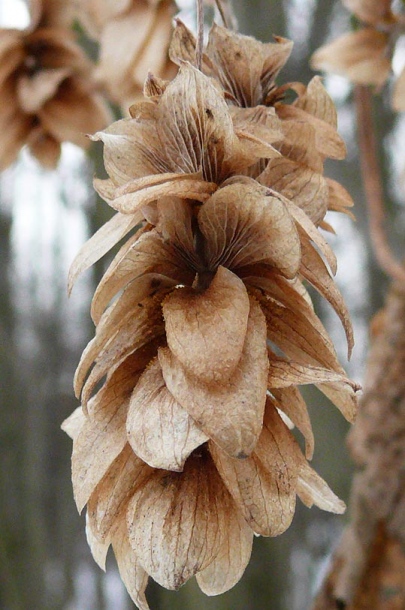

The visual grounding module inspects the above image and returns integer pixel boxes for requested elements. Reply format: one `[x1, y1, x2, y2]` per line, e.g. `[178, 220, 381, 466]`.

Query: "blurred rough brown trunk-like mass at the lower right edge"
[313, 283, 405, 610]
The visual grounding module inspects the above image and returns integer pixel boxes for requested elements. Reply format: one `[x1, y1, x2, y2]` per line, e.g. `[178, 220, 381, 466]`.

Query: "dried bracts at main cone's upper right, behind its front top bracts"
[170, 21, 352, 229]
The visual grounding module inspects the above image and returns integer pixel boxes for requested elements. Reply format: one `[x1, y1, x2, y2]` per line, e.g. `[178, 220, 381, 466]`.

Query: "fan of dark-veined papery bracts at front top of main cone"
[82, 64, 279, 214]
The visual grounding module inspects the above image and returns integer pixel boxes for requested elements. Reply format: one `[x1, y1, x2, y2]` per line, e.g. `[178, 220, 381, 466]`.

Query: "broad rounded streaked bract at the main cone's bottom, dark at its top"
[127, 451, 235, 589]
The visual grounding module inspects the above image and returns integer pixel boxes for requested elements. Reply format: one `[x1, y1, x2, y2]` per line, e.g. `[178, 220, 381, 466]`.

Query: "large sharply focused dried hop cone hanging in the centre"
[64, 23, 357, 610]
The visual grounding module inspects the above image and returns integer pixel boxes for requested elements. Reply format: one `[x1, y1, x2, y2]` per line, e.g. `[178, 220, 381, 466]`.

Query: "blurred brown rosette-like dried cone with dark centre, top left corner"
[0, 0, 111, 169]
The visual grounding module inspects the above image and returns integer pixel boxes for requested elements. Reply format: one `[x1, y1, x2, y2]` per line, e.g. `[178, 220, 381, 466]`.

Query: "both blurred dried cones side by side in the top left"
[0, 0, 176, 170]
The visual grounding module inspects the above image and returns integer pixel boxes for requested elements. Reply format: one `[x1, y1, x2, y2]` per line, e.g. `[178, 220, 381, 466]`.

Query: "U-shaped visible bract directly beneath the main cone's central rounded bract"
[159, 299, 268, 457]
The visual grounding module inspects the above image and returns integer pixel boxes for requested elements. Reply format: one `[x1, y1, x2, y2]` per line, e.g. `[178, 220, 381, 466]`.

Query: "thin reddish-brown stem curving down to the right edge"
[354, 85, 405, 282]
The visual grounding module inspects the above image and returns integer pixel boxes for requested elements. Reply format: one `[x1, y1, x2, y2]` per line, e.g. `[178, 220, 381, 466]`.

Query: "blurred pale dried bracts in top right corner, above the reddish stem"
[312, 0, 405, 111]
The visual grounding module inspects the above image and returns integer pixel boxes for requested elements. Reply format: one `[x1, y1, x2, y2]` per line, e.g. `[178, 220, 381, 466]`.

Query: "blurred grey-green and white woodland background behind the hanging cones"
[0, 0, 405, 610]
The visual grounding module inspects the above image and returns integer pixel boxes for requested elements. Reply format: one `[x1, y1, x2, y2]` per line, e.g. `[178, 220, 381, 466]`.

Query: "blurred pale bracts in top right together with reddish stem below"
[311, 0, 405, 281]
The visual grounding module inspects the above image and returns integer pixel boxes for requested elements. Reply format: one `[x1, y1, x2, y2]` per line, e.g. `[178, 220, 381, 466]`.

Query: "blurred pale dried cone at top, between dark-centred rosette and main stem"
[75, 0, 176, 111]
